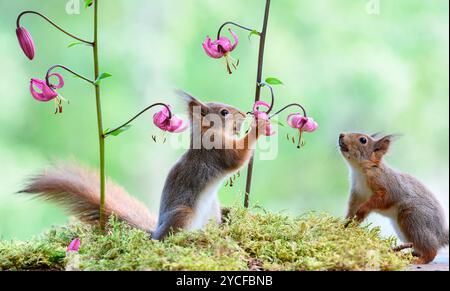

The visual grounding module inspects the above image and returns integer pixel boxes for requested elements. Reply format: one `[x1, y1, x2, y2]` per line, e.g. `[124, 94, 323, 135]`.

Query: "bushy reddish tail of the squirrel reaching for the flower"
[19, 163, 156, 232]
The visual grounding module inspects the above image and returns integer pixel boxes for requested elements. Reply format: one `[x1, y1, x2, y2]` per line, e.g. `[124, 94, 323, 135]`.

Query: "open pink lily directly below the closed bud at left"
[30, 73, 66, 113]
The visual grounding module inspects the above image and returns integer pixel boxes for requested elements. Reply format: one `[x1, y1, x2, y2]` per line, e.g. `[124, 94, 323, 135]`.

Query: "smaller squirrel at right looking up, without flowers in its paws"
[339, 133, 449, 264]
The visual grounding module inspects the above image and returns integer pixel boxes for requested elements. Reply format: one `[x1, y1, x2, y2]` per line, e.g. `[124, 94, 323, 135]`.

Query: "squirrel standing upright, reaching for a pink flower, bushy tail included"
[21, 91, 265, 240]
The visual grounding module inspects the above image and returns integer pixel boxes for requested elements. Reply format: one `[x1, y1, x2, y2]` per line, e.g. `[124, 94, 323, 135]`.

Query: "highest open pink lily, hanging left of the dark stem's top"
[203, 29, 239, 74]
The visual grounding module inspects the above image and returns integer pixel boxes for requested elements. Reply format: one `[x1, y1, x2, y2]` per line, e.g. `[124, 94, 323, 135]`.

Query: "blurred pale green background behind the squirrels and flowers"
[0, 0, 449, 239]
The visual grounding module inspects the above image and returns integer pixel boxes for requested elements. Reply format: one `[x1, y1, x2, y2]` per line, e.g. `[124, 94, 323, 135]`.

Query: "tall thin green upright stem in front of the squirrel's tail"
[92, 0, 106, 230]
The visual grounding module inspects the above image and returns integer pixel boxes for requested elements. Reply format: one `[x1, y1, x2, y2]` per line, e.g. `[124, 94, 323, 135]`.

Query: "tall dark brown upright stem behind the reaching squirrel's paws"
[244, 0, 270, 208]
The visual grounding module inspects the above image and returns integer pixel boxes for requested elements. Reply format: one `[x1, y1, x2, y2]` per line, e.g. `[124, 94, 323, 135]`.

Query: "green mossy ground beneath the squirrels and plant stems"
[0, 208, 411, 270]
